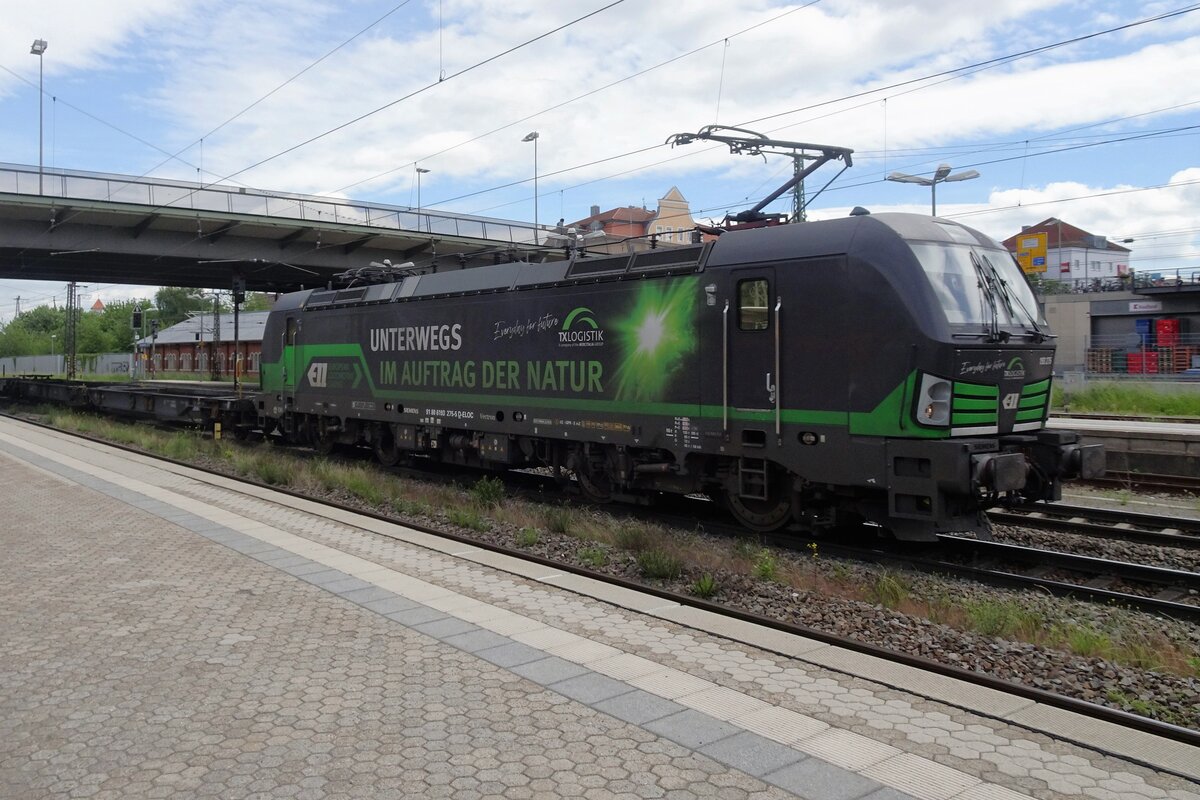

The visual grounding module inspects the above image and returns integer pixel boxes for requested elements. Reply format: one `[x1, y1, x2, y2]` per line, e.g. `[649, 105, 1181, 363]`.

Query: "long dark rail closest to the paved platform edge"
[5, 415, 1200, 746]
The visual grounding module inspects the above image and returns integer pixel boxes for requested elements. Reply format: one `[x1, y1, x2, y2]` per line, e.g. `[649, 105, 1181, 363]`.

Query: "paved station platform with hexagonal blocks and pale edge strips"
[0, 420, 1200, 800]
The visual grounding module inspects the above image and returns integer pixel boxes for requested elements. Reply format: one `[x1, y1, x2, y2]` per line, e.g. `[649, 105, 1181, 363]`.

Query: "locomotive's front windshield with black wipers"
[908, 242, 1042, 336]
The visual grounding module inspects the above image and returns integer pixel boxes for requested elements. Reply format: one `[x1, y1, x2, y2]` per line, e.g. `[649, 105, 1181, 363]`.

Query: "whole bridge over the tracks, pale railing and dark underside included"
[0, 163, 544, 291]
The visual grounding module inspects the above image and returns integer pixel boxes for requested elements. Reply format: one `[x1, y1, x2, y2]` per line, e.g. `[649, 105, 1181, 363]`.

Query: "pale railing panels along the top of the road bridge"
[0, 163, 545, 245]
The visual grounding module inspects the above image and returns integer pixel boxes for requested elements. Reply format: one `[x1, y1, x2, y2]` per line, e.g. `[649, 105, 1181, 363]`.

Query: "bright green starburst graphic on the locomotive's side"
[613, 277, 698, 403]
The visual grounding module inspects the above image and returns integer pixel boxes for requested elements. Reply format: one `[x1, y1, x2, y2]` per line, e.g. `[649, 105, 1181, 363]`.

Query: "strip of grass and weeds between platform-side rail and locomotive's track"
[37, 407, 1200, 690]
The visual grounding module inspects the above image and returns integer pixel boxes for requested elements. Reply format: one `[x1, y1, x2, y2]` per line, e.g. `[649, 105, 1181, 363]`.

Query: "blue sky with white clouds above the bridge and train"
[0, 0, 1200, 323]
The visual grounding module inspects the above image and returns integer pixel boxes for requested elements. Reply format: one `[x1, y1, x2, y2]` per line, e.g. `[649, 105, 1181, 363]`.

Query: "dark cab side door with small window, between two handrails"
[725, 267, 780, 410]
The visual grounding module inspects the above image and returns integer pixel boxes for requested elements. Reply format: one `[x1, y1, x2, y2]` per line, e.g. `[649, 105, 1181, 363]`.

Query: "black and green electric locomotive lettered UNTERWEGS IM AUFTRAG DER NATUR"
[254, 213, 1104, 540]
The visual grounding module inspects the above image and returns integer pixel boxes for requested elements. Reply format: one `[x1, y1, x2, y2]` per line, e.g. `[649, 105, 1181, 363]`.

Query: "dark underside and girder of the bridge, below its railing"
[0, 193, 544, 291]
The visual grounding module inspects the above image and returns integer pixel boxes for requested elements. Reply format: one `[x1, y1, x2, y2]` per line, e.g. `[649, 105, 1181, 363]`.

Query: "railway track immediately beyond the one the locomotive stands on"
[988, 503, 1200, 549]
